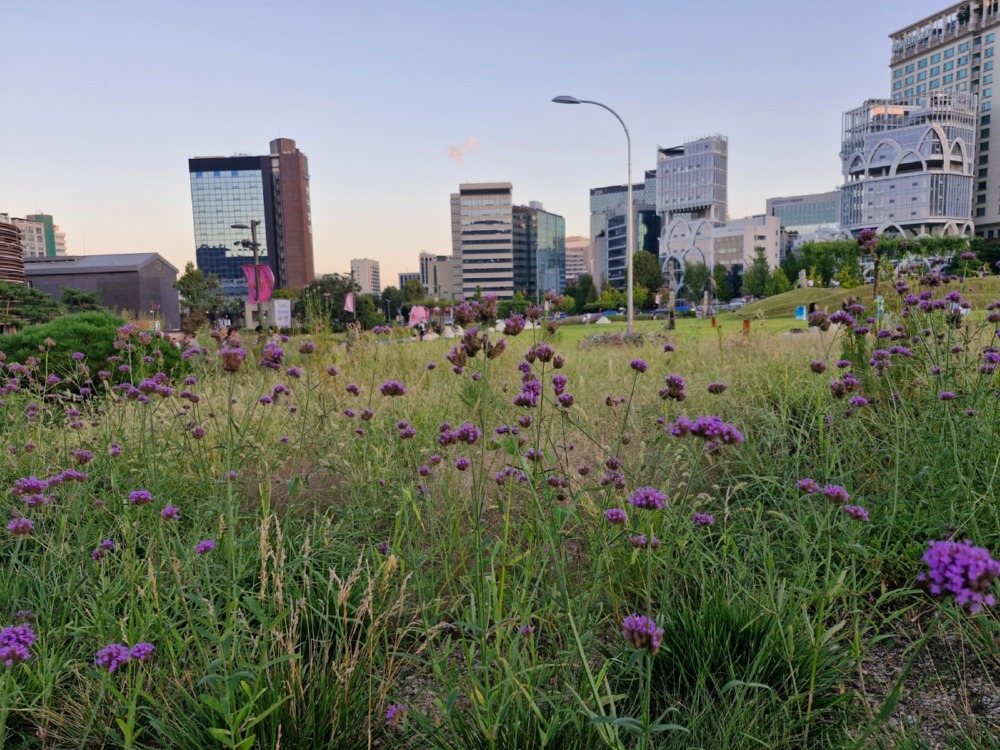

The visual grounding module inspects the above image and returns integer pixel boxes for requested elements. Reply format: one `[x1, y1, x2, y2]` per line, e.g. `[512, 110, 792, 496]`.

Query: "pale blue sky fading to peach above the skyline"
[0, 0, 947, 286]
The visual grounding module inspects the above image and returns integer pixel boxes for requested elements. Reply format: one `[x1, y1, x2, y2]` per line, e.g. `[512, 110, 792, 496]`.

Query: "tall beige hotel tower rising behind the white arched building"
[889, 0, 1000, 239]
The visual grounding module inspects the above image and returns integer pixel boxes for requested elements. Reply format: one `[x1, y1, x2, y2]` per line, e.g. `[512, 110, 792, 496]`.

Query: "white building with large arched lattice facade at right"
[840, 89, 976, 237]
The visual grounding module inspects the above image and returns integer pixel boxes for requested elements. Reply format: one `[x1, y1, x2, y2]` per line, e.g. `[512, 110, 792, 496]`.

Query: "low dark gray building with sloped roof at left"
[24, 253, 181, 330]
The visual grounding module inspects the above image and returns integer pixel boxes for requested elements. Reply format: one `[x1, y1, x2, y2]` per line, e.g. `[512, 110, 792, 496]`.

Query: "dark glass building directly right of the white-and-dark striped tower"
[513, 206, 566, 301]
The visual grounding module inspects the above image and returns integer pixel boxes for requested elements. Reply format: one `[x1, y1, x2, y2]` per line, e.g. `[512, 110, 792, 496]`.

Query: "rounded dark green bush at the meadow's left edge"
[0, 312, 187, 382]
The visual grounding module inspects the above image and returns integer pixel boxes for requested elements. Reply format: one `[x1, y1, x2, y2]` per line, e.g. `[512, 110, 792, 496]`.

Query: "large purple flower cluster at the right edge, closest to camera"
[918, 539, 1000, 612]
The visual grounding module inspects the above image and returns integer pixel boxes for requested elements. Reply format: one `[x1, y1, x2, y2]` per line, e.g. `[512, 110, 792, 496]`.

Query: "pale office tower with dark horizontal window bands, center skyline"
[451, 182, 514, 299]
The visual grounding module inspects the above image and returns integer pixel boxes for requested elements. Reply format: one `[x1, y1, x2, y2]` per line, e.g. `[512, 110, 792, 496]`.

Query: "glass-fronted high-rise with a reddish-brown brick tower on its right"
[188, 138, 315, 296]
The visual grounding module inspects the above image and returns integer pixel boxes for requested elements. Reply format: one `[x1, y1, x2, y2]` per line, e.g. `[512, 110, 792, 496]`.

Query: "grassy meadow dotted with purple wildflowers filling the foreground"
[0, 277, 1000, 749]
